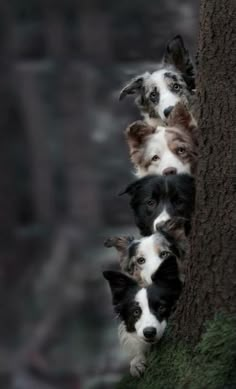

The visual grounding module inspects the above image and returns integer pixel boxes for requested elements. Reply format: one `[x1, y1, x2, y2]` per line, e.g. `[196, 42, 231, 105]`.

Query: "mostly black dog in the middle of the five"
[120, 174, 195, 236]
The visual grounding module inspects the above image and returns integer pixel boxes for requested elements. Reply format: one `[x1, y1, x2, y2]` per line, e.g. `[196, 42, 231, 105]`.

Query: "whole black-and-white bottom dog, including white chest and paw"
[103, 256, 182, 377]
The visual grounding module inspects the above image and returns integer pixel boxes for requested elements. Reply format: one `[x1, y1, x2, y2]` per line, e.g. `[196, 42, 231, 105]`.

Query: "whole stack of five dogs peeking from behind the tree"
[103, 36, 197, 377]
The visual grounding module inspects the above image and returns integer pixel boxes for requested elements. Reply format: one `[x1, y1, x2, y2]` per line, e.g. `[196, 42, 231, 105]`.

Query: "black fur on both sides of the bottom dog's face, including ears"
[103, 256, 182, 332]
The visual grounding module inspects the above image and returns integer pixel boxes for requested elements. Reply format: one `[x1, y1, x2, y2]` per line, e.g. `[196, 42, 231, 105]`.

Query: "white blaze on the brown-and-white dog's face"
[143, 126, 190, 175]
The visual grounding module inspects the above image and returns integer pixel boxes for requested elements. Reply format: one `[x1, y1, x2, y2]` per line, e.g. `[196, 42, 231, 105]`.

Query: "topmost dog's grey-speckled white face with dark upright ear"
[120, 36, 195, 124]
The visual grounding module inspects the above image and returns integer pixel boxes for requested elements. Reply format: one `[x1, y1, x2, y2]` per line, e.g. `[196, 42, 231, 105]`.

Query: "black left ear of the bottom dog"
[103, 270, 138, 305]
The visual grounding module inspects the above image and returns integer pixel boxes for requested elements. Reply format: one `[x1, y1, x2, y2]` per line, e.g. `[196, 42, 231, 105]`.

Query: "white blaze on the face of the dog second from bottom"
[137, 235, 162, 284]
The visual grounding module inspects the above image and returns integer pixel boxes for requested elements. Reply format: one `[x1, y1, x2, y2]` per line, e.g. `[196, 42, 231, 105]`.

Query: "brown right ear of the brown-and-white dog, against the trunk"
[167, 103, 197, 132]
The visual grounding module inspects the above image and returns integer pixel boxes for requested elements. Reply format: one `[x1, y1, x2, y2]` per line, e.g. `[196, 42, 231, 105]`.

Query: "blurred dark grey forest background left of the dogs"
[0, 0, 199, 389]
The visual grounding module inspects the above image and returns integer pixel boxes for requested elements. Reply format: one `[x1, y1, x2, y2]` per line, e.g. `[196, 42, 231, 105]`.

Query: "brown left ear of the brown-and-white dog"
[125, 120, 156, 153]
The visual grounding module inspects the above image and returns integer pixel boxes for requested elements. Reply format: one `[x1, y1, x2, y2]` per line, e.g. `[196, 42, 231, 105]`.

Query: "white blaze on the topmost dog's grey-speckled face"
[150, 69, 181, 121]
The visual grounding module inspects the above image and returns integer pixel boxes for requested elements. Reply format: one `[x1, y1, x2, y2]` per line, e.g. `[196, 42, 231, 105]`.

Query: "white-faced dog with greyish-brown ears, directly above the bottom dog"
[104, 218, 188, 286]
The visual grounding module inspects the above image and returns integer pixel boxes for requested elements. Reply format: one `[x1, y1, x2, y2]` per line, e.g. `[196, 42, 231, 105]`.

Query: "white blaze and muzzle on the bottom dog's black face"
[135, 288, 167, 341]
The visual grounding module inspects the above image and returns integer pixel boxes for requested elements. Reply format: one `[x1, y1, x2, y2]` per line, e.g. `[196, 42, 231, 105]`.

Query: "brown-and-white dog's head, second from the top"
[125, 103, 198, 177]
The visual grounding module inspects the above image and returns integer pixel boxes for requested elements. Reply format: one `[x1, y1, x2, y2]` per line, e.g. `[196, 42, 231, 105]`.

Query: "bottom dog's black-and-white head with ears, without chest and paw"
[103, 257, 182, 343]
